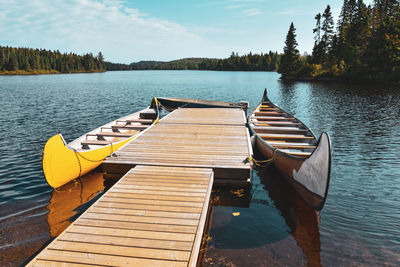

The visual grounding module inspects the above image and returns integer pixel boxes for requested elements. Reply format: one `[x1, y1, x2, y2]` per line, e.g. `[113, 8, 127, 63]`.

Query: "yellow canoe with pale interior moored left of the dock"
[42, 99, 159, 188]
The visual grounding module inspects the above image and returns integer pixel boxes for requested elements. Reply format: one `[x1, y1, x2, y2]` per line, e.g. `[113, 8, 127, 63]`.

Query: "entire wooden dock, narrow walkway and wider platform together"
[28, 108, 252, 266]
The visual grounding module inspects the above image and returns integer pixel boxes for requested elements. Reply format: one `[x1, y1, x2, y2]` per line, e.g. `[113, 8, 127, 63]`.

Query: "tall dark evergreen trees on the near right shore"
[278, 0, 400, 82]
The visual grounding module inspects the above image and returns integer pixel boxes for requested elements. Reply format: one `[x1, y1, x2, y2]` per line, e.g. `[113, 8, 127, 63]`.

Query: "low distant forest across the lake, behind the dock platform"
[105, 51, 280, 71]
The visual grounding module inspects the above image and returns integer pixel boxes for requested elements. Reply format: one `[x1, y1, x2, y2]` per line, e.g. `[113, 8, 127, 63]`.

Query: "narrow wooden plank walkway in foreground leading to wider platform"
[28, 166, 213, 266]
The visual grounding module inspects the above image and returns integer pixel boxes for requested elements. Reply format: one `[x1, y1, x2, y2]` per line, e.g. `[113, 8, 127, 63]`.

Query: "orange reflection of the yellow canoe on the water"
[47, 172, 104, 237]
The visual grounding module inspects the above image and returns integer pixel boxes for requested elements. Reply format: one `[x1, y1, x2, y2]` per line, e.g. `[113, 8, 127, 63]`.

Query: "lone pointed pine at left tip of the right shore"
[278, 22, 299, 77]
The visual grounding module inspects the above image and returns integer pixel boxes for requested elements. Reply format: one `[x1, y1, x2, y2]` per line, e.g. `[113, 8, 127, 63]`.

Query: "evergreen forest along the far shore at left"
[0, 46, 105, 74]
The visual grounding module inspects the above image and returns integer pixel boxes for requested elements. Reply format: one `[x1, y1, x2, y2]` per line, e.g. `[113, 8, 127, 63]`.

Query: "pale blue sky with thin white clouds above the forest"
[0, 0, 372, 63]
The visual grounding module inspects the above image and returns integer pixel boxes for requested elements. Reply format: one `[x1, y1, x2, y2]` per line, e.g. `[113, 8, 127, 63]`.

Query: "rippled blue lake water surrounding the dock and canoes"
[0, 71, 400, 266]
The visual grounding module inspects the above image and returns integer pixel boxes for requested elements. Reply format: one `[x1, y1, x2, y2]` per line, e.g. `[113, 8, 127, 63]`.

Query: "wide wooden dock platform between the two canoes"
[103, 108, 252, 186]
